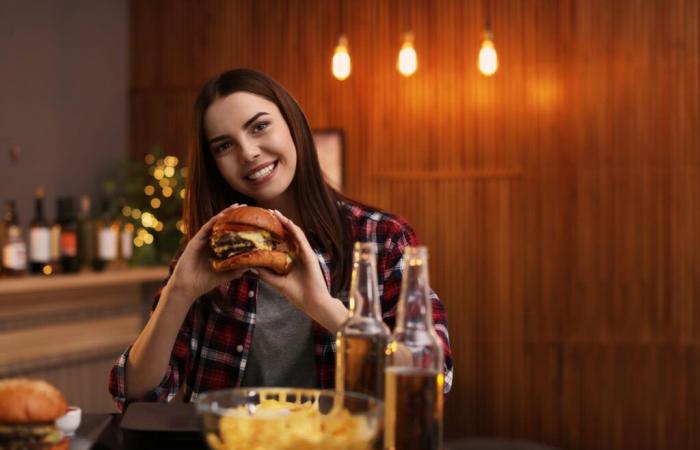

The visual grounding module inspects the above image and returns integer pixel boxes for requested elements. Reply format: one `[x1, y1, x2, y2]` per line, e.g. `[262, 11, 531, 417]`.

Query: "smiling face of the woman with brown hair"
[204, 92, 297, 210]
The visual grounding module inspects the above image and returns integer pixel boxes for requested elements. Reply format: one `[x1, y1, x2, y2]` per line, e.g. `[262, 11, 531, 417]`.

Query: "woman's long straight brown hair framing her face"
[184, 69, 352, 295]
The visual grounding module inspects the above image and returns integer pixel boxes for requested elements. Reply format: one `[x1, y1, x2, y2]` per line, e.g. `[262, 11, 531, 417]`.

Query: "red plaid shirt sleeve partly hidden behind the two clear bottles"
[377, 219, 453, 393]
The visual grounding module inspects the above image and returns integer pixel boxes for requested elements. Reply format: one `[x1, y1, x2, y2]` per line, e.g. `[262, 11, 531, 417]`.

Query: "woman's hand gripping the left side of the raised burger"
[168, 204, 247, 303]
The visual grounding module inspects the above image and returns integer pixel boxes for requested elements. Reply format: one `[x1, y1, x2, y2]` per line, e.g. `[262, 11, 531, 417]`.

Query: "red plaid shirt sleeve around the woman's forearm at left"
[109, 260, 193, 411]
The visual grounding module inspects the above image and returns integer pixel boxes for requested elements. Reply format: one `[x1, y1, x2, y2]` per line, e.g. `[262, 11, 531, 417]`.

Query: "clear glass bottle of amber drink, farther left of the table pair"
[335, 242, 389, 399]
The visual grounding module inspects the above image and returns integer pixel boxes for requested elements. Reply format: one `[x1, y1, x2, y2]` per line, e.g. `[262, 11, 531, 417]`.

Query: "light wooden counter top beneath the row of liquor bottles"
[0, 266, 168, 296]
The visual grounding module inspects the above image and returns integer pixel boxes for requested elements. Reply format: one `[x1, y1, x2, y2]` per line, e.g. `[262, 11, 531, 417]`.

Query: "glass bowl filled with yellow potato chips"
[196, 388, 384, 450]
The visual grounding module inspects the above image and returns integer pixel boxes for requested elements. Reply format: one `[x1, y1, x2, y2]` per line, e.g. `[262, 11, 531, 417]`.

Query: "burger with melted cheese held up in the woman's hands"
[209, 206, 294, 275]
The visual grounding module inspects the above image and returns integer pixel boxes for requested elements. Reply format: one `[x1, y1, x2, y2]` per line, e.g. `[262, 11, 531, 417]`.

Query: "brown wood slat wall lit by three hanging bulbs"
[130, 0, 700, 450]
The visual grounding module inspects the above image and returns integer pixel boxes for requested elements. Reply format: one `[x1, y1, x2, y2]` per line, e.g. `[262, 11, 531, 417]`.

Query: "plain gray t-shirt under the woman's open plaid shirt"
[241, 281, 316, 387]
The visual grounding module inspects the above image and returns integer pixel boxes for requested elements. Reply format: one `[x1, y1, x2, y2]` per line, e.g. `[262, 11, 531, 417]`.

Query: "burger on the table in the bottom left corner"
[0, 378, 70, 450]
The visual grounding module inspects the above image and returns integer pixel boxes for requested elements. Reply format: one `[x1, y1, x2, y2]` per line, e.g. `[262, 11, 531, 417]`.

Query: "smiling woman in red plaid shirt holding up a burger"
[109, 69, 452, 408]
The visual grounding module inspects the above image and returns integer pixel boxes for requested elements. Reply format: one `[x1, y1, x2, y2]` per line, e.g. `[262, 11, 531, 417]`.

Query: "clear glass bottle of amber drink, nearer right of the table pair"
[384, 246, 444, 450]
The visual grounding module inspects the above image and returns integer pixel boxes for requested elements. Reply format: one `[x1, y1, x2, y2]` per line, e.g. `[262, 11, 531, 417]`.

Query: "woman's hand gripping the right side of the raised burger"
[256, 211, 347, 332]
